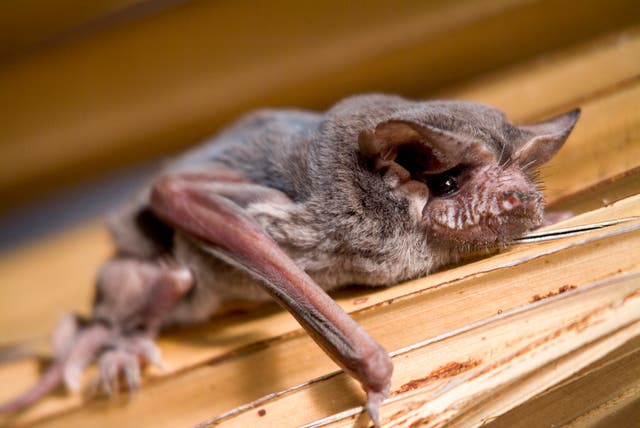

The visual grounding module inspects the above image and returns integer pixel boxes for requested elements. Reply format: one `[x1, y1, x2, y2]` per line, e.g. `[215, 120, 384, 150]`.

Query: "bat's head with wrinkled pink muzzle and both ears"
[359, 98, 580, 252]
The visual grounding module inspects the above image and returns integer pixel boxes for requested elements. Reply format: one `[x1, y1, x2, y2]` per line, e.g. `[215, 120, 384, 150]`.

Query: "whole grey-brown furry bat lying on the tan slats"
[0, 95, 579, 424]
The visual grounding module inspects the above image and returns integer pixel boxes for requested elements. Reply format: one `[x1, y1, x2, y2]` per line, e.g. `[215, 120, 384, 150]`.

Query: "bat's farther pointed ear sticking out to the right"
[514, 108, 580, 168]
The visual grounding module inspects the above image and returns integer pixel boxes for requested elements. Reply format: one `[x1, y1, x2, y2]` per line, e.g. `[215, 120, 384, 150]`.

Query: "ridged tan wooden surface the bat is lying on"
[0, 2, 640, 427]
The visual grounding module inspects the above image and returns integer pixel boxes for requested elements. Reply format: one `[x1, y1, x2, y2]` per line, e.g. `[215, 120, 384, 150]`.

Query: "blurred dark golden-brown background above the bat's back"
[0, 0, 640, 250]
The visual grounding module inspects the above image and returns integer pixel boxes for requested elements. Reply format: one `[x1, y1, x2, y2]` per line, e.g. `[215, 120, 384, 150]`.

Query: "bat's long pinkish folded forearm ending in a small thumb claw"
[151, 175, 393, 424]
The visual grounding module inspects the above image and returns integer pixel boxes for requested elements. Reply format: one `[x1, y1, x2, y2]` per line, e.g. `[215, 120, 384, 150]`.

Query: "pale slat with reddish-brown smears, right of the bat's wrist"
[296, 274, 640, 427]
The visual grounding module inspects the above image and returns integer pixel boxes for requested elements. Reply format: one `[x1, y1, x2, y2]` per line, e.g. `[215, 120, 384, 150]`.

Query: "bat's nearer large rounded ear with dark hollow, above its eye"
[358, 120, 495, 174]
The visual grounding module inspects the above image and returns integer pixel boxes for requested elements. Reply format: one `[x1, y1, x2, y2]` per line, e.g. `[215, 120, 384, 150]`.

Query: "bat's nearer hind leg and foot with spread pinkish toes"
[82, 259, 193, 394]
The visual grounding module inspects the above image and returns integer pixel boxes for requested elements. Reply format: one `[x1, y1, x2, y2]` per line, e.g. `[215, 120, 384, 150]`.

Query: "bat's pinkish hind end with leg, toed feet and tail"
[0, 259, 193, 414]
